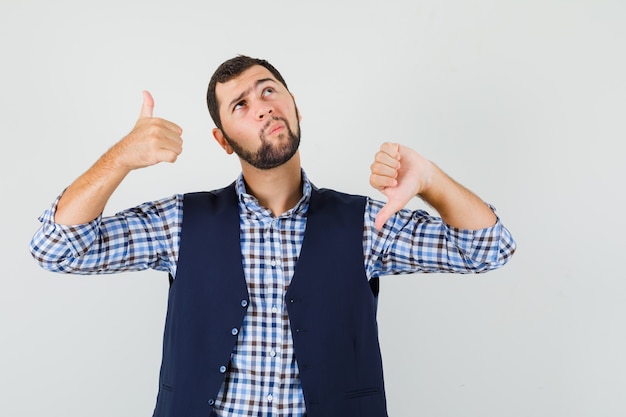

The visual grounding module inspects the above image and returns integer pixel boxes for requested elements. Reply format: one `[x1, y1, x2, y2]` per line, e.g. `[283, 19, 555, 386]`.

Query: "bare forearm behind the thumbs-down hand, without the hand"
[419, 164, 497, 230]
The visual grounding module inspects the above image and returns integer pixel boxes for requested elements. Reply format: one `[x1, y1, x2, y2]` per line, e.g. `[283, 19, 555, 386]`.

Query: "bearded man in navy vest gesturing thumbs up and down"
[31, 56, 515, 417]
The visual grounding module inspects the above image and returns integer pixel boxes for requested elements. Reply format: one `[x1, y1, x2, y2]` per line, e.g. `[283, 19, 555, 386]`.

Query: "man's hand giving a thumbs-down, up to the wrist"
[370, 142, 433, 230]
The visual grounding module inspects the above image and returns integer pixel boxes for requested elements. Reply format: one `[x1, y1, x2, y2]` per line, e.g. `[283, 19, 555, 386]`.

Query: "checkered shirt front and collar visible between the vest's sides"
[214, 176, 311, 417]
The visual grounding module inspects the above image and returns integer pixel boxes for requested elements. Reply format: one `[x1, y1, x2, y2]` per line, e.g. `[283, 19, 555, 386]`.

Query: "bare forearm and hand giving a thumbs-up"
[54, 91, 183, 225]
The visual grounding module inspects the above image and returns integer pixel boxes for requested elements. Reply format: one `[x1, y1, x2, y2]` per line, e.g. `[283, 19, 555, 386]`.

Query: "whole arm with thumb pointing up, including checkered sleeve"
[30, 92, 182, 274]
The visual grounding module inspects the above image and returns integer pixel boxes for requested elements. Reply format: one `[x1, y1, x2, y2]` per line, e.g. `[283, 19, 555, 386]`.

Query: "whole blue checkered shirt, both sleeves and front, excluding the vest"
[31, 172, 516, 417]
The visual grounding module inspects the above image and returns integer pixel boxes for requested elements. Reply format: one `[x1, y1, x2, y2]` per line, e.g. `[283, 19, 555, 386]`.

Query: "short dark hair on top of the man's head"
[206, 55, 289, 130]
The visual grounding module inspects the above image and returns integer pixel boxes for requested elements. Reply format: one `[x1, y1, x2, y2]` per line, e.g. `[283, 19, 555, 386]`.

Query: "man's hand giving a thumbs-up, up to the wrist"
[112, 91, 183, 170]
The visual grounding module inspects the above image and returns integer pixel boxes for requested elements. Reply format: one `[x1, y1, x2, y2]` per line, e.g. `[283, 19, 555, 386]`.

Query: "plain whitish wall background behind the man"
[0, 0, 626, 417]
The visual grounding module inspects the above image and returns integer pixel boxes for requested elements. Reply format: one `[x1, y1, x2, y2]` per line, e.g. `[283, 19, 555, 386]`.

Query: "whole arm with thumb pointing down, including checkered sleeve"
[364, 143, 516, 277]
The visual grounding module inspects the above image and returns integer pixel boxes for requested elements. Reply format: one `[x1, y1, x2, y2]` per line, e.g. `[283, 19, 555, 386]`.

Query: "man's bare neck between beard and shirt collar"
[241, 152, 302, 216]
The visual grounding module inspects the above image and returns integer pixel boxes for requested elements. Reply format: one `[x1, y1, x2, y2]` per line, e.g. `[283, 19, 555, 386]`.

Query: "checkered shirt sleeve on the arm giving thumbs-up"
[30, 195, 182, 274]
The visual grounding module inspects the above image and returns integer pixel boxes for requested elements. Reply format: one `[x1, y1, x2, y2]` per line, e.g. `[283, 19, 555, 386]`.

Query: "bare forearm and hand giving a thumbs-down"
[370, 142, 497, 230]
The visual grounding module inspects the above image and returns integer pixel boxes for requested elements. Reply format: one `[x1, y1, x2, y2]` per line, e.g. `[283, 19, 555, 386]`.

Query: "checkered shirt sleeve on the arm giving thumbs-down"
[363, 199, 516, 278]
